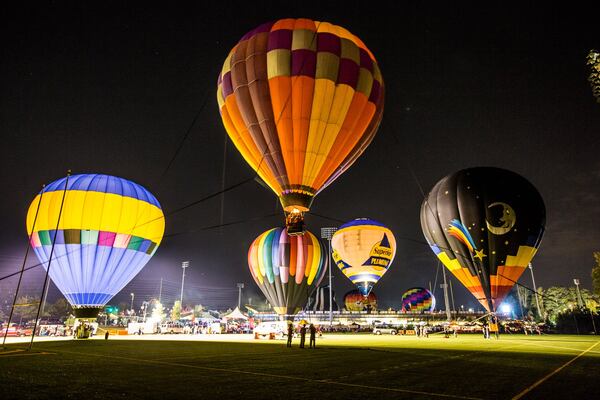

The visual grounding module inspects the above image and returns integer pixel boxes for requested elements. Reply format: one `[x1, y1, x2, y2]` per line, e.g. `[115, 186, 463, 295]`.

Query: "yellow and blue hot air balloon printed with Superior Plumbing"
[331, 218, 396, 296]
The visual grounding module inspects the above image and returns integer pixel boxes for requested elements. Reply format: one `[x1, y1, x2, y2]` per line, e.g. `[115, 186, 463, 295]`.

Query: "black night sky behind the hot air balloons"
[0, 1, 600, 305]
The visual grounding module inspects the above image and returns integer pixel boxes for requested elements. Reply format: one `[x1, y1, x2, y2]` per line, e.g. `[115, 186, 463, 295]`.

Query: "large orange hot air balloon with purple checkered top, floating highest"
[217, 19, 384, 234]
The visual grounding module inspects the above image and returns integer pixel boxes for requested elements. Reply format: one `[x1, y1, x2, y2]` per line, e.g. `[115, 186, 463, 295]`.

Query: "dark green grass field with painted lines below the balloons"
[0, 335, 600, 400]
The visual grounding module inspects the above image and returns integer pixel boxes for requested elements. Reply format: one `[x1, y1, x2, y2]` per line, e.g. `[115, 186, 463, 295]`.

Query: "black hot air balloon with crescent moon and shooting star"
[421, 167, 546, 312]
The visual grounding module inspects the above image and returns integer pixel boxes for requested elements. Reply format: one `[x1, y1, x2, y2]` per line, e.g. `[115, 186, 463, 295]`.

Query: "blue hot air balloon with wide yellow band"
[27, 174, 165, 318]
